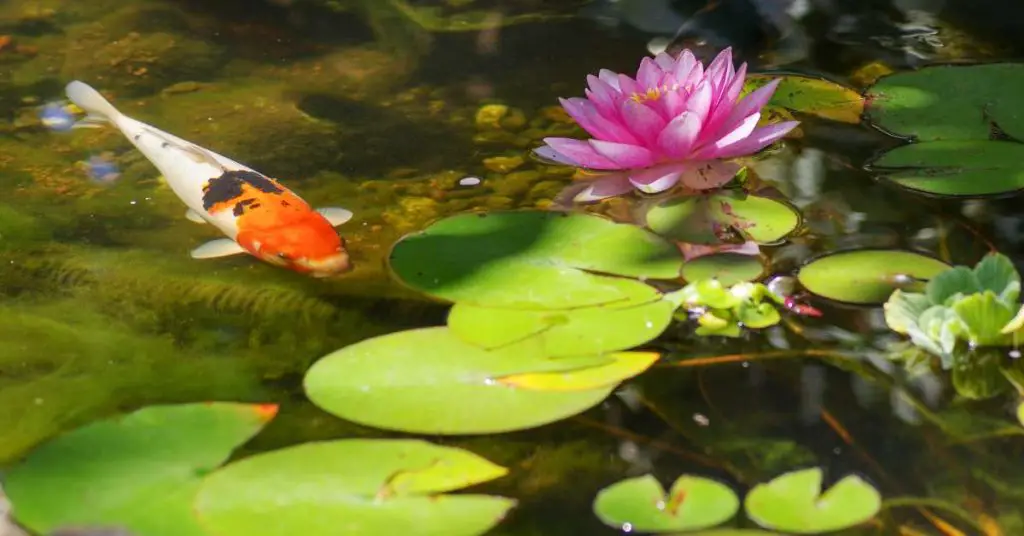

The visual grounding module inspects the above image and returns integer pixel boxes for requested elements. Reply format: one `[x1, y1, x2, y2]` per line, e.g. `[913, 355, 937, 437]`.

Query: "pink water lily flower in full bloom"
[535, 48, 799, 202]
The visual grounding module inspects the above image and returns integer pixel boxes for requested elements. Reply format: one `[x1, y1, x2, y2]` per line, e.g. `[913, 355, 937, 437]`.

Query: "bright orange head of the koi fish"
[238, 218, 352, 278]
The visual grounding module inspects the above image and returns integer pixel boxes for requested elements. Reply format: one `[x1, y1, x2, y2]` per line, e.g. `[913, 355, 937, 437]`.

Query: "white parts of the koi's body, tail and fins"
[66, 80, 352, 258]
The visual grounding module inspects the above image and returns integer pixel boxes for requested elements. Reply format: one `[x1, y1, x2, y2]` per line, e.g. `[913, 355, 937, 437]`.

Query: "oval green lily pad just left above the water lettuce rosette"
[797, 249, 950, 304]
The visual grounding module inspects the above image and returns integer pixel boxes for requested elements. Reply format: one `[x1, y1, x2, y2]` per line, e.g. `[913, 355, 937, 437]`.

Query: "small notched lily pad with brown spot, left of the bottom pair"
[594, 475, 739, 532]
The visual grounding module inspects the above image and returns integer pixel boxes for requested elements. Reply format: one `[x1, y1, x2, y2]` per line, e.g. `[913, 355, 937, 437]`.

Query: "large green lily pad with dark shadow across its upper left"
[389, 210, 682, 308]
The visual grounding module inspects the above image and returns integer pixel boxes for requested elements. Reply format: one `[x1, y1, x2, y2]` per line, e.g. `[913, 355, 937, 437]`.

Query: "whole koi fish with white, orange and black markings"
[65, 80, 352, 278]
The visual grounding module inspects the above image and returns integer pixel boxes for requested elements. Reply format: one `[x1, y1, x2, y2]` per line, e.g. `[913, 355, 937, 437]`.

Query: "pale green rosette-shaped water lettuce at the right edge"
[885, 253, 1024, 369]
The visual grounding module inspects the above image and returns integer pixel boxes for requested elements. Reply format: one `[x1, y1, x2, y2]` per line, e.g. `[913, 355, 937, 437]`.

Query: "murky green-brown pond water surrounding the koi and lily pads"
[0, 0, 1024, 536]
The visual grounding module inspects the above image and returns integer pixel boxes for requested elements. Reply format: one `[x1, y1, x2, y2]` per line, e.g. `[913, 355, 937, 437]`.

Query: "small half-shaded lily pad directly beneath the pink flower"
[644, 194, 801, 244]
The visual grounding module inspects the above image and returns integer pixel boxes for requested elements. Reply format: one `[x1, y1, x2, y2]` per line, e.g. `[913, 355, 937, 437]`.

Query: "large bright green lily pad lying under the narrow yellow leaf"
[304, 328, 647, 434]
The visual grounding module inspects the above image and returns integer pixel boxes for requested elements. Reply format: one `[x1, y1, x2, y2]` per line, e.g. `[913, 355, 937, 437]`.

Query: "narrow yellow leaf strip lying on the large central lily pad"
[498, 352, 662, 390]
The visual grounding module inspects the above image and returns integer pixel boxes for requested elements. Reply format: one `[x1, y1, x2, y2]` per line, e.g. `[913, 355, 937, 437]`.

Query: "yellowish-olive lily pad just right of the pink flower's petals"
[742, 73, 864, 123]
